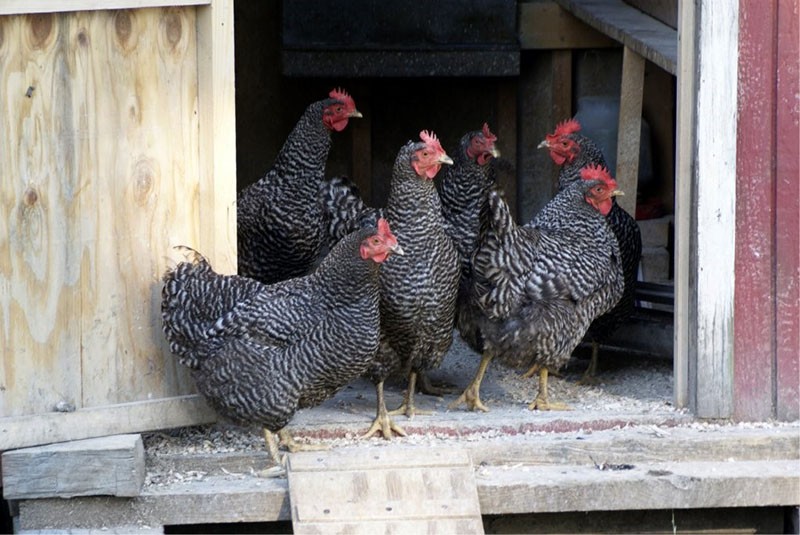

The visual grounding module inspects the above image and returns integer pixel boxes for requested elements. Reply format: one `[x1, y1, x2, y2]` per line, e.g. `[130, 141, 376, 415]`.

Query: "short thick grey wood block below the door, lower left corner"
[2, 435, 145, 500]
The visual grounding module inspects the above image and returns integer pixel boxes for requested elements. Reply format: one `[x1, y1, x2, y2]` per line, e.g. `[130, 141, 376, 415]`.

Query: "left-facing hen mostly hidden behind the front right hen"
[539, 119, 642, 382]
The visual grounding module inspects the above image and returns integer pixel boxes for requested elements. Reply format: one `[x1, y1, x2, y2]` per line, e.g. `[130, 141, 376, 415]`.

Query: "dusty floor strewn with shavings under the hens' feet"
[145, 335, 680, 482]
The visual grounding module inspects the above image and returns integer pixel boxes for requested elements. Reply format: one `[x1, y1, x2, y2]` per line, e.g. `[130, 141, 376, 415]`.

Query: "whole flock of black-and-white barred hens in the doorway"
[161, 89, 641, 461]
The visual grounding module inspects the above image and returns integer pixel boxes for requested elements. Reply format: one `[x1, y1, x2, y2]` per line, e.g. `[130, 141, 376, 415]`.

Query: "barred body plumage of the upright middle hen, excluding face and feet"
[366, 142, 460, 383]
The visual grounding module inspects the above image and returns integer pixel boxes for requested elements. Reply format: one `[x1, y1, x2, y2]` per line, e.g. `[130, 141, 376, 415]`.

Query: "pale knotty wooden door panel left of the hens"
[0, 0, 236, 450]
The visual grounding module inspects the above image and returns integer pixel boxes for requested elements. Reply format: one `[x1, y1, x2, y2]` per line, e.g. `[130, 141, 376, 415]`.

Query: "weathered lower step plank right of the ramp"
[476, 461, 800, 514]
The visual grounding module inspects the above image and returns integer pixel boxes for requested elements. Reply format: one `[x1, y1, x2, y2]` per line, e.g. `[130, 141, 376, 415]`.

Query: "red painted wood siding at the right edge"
[734, 0, 800, 420]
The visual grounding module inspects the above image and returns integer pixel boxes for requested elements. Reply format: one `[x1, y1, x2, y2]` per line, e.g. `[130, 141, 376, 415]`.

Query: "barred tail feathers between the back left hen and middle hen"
[318, 176, 384, 249]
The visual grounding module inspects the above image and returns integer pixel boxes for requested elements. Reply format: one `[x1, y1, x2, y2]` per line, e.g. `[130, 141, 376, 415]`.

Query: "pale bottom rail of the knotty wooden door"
[0, 395, 217, 451]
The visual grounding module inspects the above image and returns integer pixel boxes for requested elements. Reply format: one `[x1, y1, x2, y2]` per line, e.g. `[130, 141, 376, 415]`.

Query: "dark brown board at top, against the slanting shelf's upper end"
[517, 0, 619, 50]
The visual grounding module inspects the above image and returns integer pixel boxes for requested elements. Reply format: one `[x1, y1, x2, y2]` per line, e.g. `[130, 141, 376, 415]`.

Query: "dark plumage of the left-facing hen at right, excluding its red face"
[558, 134, 642, 342]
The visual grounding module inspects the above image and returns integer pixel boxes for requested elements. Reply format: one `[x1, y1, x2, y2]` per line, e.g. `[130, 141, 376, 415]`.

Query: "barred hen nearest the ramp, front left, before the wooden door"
[161, 220, 402, 461]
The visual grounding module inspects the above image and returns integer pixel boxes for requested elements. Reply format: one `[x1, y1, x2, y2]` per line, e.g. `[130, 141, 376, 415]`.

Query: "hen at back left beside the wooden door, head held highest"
[236, 89, 361, 284]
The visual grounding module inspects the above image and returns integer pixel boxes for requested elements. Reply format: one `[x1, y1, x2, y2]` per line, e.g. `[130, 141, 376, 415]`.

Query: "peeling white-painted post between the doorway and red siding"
[676, 0, 739, 418]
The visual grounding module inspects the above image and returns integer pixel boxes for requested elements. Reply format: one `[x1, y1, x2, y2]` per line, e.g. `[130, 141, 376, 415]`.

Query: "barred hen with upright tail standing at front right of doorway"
[451, 167, 623, 411]
